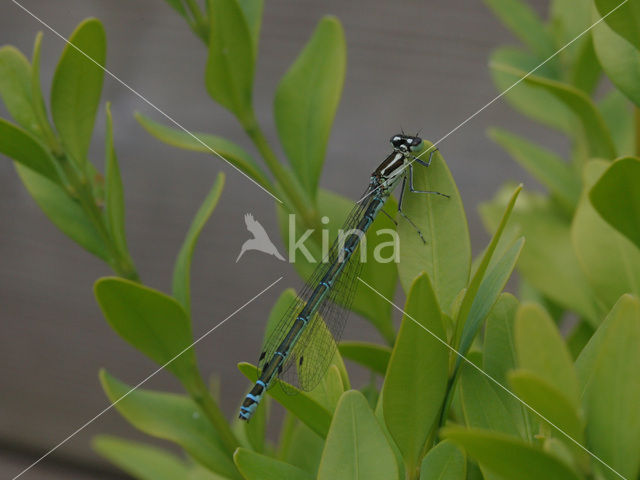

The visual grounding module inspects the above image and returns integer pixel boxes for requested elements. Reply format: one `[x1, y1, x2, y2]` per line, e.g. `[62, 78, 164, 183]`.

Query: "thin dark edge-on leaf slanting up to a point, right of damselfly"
[453, 185, 522, 353]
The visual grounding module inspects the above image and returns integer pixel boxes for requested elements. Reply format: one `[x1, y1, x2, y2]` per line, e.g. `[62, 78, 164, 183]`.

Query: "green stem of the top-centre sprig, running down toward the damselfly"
[241, 113, 320, 229]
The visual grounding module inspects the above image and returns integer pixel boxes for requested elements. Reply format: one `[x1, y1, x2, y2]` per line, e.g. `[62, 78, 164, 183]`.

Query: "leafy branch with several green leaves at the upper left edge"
[0, 19, 138, 280]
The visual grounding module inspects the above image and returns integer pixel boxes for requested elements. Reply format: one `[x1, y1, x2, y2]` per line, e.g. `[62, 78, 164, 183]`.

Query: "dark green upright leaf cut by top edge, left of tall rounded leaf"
[205, 0, 256, 121]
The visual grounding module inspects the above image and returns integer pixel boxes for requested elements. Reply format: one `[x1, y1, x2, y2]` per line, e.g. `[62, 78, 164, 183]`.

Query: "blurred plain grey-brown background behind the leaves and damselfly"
[0, 0, 565, 480]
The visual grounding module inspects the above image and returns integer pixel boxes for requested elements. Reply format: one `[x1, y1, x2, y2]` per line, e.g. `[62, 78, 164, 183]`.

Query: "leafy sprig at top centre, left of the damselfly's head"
[146, 0, 346, 228]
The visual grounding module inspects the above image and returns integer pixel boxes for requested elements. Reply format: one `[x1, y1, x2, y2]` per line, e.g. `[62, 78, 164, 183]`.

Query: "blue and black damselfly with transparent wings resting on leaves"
[240, 134, 448, 420]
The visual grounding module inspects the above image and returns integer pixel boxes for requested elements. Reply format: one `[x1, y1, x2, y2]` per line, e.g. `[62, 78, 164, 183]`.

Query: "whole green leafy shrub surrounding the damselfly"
[0, 0, 640, 480]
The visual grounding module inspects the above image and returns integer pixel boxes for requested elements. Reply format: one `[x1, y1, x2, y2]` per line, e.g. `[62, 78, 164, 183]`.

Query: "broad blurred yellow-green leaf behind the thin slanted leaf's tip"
[480, 186, 600, 325]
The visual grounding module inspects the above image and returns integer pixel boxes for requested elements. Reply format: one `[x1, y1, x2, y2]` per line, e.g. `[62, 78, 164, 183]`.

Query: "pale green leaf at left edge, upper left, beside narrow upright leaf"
[0, 45, 40, 138]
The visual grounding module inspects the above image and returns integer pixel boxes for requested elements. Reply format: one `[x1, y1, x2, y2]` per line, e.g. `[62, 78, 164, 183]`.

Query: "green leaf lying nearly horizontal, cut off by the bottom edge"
[442, 428, 580, 480]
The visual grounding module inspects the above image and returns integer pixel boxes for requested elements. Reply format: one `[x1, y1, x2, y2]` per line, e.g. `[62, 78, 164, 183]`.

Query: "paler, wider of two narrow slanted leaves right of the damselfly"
[457, 237, 524, 363]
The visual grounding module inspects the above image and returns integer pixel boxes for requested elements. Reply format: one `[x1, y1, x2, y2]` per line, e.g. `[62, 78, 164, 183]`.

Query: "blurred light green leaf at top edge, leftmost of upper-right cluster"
[485, 0, 556, 58]
